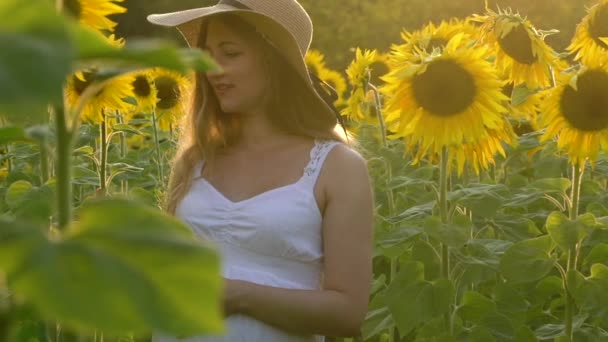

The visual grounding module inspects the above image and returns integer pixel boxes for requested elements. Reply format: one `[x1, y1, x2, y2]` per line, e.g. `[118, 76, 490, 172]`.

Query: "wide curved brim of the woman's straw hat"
[147, 4, 333, 121]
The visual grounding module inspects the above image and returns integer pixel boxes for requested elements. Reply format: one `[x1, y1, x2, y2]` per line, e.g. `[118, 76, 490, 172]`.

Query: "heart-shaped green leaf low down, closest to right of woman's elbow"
[386, 262, 454, 336]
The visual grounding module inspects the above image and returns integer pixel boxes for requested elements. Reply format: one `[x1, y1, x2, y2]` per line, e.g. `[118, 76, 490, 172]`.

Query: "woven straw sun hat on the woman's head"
[148, 0, 341, 119]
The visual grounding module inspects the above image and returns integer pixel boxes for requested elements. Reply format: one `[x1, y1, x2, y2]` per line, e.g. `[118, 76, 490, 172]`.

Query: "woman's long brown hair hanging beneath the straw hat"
[164, 14, 344, 214]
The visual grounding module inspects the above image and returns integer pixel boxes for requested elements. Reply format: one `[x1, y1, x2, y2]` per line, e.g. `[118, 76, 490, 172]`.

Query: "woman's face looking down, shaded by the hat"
[204, 19, 268, 115]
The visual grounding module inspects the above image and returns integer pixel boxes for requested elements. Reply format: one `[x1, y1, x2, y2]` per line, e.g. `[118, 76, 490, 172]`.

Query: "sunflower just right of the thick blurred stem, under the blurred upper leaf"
[65, 69, 134, 123]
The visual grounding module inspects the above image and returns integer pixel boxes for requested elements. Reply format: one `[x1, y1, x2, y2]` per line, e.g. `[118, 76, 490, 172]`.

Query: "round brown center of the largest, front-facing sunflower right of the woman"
[412, 59, 477, 116]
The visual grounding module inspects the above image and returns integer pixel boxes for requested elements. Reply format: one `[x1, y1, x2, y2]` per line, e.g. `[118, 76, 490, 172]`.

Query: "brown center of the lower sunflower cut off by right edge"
[560, 70, 608, 132]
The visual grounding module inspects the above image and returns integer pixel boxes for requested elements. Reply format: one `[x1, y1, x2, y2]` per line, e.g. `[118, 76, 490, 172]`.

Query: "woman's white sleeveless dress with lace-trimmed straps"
[152, 141, 339, 342]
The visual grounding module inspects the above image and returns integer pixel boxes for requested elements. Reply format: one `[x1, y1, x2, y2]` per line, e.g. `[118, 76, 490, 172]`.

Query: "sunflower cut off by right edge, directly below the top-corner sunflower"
[541, 67, 608, 166]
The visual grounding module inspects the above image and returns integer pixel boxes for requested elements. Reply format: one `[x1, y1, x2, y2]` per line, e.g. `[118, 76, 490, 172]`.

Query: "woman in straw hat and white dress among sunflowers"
[148, 0, 373, 342]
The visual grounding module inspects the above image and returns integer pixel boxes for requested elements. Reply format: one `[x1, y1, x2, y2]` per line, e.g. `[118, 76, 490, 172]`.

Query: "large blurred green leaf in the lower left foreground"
[7, 199, 223, 336]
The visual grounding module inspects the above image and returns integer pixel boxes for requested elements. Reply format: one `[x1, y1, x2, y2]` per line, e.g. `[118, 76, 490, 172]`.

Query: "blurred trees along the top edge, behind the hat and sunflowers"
[116, 0, 592, 70]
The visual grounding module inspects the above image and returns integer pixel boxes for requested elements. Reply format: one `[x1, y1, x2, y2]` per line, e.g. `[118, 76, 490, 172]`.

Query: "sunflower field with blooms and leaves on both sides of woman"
[0, 0, 608, 342]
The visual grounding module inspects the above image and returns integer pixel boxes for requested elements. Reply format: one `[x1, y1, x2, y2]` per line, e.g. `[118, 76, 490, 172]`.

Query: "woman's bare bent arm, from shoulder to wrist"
[225, 146, 373, 336]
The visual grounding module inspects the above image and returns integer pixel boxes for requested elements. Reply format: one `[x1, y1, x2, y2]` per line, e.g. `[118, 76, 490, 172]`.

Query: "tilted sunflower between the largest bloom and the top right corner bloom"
[471, 9, 564, 89]
